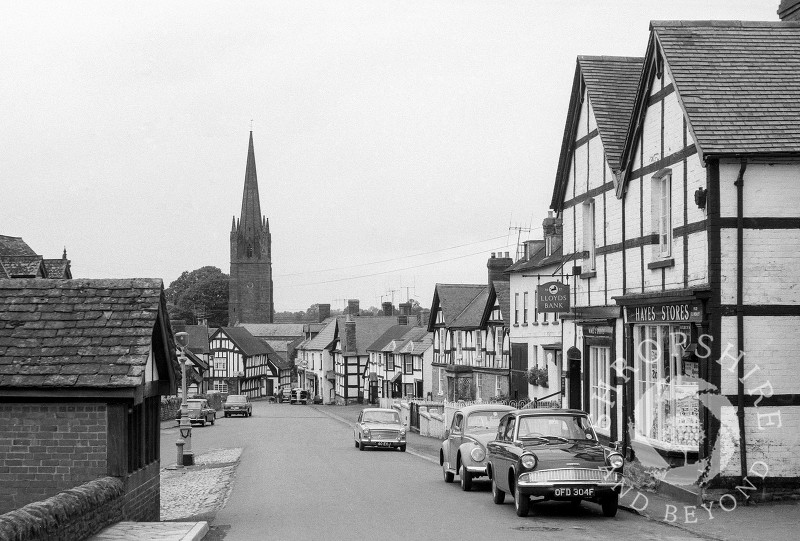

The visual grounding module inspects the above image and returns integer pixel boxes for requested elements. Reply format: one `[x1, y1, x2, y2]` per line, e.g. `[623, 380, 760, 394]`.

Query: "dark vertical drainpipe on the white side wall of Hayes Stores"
[735, 158, 749, 498]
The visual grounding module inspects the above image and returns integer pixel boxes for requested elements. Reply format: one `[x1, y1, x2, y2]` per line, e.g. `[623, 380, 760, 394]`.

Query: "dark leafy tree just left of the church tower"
[164, 266, 230, 327]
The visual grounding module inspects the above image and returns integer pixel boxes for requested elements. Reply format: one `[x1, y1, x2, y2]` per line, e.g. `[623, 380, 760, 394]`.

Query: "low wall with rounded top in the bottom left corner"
[0, 477, 123, 541]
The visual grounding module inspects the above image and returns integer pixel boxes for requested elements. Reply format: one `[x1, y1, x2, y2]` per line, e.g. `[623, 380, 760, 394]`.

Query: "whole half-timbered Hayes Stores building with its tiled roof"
[608, 21, 800, 492]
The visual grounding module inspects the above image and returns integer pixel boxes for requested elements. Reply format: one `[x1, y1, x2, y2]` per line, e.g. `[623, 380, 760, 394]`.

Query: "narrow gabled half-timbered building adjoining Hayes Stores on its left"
[542, 56, 642, 441]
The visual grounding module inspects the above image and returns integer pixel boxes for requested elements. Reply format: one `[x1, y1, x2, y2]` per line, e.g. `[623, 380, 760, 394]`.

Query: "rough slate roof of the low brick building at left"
[0, 279, 178, 389]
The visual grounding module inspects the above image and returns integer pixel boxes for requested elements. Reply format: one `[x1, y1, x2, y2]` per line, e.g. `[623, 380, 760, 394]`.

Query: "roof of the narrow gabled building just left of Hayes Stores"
[550, 56, 644, 210]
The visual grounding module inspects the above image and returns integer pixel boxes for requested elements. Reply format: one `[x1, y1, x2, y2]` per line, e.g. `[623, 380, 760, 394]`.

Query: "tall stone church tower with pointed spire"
[228, 131, 274, 326]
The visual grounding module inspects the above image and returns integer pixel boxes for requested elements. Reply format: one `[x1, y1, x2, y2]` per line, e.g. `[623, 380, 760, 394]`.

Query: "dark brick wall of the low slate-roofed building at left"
[0, 403, 107, 513]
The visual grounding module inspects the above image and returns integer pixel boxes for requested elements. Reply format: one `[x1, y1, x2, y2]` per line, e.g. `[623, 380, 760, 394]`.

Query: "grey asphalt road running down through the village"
[162, 402, 698, 541]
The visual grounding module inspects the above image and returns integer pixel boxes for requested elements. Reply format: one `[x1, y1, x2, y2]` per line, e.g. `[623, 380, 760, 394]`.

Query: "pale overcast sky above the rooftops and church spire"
[0, 0, 780, 311]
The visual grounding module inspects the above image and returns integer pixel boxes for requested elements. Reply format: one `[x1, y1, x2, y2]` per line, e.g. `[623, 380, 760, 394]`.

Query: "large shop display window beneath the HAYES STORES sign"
[634, 324, 700, 450]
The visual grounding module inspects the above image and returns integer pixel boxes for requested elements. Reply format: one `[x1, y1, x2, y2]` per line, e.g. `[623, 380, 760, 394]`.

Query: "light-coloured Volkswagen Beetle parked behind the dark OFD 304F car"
[439, 404, 514, 490]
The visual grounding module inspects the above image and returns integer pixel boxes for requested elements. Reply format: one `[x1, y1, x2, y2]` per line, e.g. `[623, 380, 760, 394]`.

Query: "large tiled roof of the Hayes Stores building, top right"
[648, 21, 800, 155]
